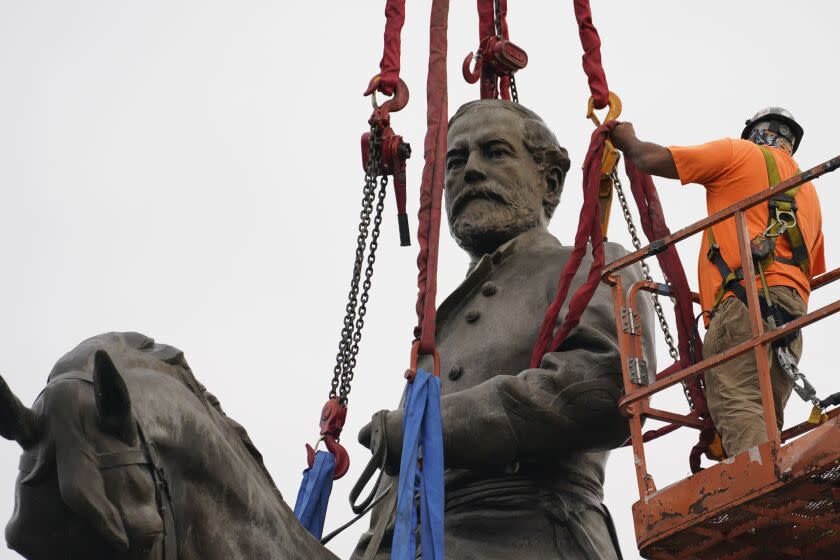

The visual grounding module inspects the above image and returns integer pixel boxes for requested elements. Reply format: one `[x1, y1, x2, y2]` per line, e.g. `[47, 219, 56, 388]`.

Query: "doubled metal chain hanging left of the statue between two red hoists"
[329, 126, 380, 399]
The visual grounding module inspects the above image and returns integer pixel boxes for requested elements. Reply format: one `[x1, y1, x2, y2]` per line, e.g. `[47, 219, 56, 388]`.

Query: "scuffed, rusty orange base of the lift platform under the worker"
[633, 418, 840, 560]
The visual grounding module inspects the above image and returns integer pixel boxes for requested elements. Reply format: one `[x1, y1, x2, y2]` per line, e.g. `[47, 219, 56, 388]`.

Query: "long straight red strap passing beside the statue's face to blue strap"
[414, 0, 449, 354]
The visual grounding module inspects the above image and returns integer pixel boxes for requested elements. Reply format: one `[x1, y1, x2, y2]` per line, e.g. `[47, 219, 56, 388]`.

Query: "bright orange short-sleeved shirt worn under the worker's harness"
[669, 138, 825, 325]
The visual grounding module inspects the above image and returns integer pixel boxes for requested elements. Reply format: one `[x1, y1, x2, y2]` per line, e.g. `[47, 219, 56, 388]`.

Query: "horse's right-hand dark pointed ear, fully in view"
[93, 350, 137, 444]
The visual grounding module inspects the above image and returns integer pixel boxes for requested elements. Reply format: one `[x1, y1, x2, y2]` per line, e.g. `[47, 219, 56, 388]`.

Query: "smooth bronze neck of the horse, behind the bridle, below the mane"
[131, 370, 331, 560]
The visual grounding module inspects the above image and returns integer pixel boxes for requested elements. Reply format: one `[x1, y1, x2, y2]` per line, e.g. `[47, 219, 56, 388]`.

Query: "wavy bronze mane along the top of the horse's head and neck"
[47, 332, 280, 495]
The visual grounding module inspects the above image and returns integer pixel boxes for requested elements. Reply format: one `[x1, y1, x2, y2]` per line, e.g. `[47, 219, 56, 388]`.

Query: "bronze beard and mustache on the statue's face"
[448, 185, 543, 255]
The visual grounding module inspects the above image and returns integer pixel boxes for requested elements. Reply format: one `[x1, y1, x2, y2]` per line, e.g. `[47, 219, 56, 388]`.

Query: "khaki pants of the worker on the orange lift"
[703, 286, 806, 457]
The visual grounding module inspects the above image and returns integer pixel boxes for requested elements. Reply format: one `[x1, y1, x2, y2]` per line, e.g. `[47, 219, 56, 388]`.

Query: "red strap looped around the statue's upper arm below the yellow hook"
[531, 121, 615, 367]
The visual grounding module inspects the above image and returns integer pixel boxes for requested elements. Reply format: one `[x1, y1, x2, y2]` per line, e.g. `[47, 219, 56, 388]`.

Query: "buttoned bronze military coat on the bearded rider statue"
[353, 227, 655, 560]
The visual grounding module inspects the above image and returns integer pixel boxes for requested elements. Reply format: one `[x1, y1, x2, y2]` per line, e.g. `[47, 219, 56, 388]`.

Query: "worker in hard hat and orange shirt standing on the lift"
[611, 107, 825, 457]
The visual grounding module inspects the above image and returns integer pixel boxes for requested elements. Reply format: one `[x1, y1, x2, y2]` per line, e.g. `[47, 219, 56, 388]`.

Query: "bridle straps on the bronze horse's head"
[44, 372, 178, 560]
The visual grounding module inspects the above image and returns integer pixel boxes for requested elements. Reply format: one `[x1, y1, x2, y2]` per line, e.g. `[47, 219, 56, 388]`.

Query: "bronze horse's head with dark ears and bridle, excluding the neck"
[0, 334, 176, 560]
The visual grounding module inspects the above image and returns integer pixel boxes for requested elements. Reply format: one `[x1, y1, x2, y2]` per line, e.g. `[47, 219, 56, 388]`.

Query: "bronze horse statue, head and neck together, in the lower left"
[0, 333, 336, 560]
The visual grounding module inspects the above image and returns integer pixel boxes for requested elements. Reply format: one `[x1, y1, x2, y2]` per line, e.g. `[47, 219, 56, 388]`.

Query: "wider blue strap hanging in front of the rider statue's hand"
[391, 369, 444, 560]
